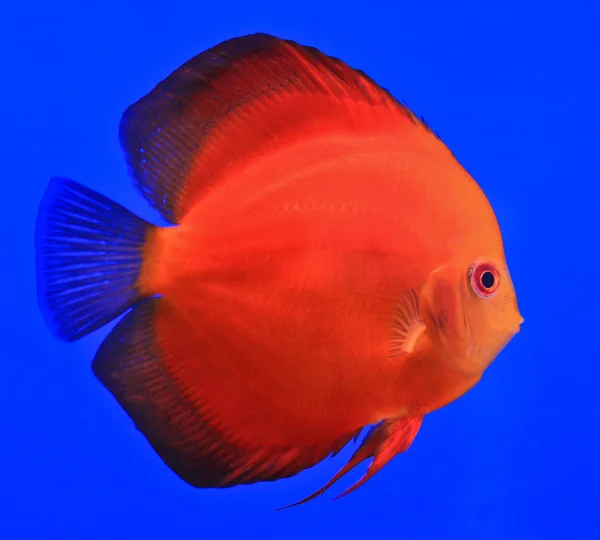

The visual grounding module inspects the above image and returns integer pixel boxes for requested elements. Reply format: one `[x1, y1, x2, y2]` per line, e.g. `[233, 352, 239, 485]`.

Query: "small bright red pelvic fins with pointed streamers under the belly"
[278, 416, 423, 510]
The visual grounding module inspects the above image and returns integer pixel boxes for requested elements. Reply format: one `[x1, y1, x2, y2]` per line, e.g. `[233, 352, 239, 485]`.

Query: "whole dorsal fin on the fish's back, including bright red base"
[120, 34, 426, 223]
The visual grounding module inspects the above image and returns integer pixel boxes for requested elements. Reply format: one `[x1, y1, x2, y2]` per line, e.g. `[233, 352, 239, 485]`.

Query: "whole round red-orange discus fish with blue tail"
[36, 34, 523, 502]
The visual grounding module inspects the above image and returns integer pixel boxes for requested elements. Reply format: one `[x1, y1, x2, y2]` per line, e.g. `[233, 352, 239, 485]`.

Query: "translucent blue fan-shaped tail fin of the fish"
[35, 178, 154, 341]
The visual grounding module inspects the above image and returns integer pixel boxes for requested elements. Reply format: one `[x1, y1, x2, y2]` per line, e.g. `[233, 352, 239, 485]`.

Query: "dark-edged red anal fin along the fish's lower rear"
[93, 297, 357, 487]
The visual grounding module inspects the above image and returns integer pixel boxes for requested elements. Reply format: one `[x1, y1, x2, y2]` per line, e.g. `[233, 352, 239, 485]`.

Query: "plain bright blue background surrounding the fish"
[0, 0, 600, 540]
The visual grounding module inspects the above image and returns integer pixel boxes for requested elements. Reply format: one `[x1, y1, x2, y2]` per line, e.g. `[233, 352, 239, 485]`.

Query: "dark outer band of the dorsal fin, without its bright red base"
[119, 33, 433, 223]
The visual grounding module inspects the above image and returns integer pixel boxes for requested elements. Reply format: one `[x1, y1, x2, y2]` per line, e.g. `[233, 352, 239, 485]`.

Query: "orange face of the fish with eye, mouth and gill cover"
[421, 257, 523, 375]
